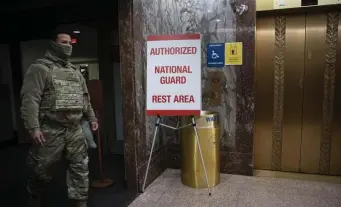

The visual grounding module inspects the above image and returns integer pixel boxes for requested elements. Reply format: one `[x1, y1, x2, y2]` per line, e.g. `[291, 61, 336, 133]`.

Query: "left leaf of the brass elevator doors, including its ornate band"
[254, 15, 305, 172]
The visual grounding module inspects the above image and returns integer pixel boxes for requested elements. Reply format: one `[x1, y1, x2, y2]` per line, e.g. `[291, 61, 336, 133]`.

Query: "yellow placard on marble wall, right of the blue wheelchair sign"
[225, 42, 243, 65]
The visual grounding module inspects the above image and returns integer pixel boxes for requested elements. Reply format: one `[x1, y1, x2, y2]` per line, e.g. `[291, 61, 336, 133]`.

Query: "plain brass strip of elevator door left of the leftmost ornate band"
[254, 17, 275, 170]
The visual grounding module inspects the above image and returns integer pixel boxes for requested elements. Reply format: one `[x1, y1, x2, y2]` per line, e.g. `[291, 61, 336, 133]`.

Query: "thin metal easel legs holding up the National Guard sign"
[142, 115, 211, 195]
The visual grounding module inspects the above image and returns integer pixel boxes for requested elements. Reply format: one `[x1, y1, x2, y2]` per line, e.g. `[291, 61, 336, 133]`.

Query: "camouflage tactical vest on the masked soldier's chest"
[37, 59, 84, 111]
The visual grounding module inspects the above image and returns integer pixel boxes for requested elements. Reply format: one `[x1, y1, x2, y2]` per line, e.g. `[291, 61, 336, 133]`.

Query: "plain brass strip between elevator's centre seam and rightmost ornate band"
[300, 14, 327, 173]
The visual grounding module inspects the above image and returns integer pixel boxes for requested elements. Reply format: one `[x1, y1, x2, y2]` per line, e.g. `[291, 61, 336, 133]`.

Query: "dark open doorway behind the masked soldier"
[0, 4, 136, 207]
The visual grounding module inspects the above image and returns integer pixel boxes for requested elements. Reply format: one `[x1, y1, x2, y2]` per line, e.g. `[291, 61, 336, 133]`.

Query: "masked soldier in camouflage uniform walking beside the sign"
[21, 26, 98, 207]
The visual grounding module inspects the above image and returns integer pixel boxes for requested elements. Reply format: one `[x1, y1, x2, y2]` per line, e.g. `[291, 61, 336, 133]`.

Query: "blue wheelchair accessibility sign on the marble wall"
[206, 43, 225, 67]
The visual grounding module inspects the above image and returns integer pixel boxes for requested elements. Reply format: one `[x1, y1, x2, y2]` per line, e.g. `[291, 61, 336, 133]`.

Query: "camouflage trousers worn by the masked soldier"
[27, 123, 89, 200]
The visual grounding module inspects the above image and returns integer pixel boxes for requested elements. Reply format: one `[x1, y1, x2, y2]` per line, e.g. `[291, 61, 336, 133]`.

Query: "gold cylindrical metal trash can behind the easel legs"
[180, 111, 220, 188]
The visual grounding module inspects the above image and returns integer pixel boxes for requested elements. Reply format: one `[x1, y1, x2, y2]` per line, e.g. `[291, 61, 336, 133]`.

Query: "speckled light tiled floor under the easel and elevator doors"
[130, 169, 341, 207]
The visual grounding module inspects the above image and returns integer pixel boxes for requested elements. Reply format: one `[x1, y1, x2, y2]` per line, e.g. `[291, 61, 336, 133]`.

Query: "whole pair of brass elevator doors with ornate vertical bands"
[254, 13, 341, 175]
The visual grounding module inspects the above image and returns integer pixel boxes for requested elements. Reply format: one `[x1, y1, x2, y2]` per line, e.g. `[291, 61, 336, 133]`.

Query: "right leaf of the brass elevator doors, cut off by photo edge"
[300, 12, 341, 175]
